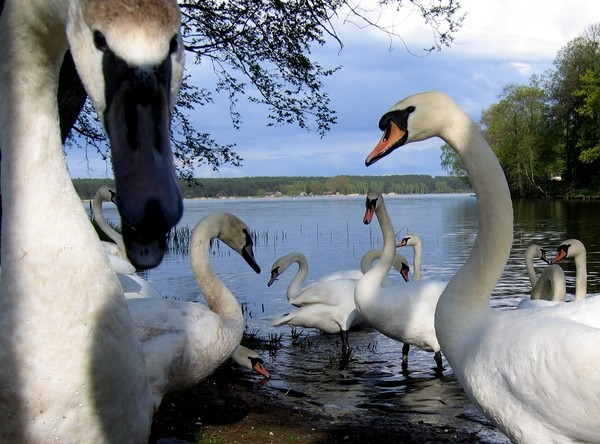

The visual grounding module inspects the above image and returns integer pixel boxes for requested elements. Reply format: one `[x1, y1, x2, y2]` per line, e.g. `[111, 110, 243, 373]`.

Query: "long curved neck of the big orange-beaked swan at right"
[436, 102, 513, 330]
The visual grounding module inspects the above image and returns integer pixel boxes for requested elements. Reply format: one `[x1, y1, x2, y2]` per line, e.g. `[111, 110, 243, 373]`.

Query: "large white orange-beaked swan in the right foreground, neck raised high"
[365, 92, 600, 443]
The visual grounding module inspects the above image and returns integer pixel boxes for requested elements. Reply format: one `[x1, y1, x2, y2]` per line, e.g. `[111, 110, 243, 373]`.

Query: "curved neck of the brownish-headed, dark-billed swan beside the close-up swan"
[190, 219, 244, 322]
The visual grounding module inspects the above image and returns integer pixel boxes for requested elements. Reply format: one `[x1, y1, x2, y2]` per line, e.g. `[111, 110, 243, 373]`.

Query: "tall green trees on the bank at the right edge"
[478, 24, 600, 197]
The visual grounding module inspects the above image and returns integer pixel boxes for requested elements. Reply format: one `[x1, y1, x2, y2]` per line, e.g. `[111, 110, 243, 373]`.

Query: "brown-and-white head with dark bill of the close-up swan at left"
[67, 0, 184, 269]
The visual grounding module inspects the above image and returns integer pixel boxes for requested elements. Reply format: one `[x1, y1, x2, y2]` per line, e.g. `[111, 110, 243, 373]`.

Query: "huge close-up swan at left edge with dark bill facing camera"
[0, 0, 183, 443]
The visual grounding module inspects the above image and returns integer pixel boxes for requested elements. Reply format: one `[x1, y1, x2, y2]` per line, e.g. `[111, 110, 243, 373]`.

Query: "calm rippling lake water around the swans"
[105, 195, 600, 441]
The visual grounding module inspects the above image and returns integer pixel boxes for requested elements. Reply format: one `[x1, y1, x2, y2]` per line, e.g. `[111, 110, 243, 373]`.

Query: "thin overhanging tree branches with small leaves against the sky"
[59, 0, 464, 179]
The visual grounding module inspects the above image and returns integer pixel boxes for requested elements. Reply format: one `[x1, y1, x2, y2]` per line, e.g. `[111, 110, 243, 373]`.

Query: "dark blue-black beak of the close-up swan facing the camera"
[103, 57, 183, 269]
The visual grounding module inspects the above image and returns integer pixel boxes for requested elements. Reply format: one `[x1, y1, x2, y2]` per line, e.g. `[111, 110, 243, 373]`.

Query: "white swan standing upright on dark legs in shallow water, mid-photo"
[354, 191, 446, 370]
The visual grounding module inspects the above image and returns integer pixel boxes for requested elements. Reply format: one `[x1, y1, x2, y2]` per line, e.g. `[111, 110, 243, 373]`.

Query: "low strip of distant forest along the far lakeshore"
[73, 174, 472, 199]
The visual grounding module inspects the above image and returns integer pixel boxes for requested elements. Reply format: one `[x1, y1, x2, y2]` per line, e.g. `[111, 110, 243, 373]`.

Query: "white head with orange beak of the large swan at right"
[365, 91, 456, 166]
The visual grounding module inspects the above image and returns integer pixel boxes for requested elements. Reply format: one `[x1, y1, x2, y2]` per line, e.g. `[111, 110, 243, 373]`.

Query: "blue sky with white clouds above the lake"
[67, 0, 600, 178]
